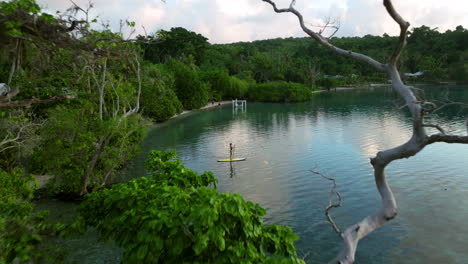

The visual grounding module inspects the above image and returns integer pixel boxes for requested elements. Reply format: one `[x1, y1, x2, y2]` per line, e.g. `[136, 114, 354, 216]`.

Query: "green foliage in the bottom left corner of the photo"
[0, 169, 61, 263]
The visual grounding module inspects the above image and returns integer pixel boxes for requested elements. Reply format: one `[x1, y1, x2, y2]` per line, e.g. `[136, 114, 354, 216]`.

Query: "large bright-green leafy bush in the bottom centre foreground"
[80, 152, 304, 263]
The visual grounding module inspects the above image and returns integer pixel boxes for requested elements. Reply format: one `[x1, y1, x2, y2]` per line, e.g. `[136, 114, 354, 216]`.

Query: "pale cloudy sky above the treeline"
[37, 0, 468, 43]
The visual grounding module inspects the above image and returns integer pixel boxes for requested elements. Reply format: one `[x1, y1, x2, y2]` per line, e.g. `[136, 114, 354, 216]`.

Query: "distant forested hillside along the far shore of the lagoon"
[140, 23, 468, 89]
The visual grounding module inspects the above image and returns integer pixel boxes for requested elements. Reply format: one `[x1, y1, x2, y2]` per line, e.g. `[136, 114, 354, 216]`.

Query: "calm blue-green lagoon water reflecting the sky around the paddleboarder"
[39, 86, 468, 264]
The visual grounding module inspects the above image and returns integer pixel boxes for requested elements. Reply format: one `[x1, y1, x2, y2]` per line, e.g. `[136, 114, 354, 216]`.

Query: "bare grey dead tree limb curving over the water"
[262, 0, 468, 264]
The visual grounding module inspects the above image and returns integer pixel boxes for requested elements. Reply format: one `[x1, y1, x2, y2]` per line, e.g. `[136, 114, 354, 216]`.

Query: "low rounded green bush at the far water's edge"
[248, 82, 312, 102]
